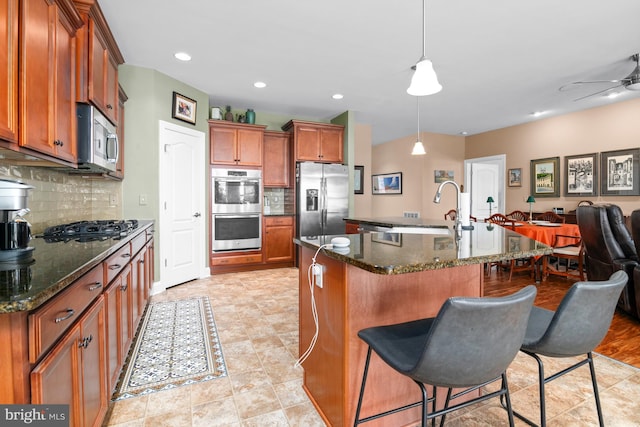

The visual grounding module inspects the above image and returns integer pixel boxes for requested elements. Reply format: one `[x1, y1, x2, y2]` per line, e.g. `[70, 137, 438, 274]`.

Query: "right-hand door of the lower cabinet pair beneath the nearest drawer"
[78, 299, 109, 426]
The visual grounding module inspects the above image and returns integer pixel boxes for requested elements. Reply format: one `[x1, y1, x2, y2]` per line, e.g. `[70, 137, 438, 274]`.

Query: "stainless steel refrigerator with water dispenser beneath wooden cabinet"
[296, 162, 349, 236]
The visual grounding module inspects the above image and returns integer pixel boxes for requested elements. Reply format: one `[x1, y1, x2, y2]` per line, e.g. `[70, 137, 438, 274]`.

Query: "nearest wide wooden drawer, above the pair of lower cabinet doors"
[29, 265, 104, 363]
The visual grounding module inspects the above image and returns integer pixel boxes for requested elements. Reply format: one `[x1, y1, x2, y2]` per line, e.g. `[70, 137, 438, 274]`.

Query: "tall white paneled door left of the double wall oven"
[159, 121, 206, 288]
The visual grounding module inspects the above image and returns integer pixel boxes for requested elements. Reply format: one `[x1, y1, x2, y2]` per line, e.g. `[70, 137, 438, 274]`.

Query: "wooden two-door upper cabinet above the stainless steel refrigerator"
[282, 120, 344, 163]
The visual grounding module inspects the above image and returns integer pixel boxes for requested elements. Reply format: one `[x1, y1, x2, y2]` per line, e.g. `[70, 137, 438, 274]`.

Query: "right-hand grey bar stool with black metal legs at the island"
[508, 270, 628, 427]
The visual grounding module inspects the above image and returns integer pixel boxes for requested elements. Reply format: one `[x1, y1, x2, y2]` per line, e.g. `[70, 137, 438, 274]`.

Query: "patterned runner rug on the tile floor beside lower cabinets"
[113, 297, 227, 400]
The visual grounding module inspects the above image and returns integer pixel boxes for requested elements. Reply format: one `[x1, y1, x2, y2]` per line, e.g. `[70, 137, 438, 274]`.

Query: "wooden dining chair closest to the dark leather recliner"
[542, 234, 585, 280]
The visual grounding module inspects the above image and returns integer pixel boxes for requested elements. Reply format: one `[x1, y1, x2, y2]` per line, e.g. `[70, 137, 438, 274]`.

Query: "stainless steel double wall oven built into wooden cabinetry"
[211, 168, 262, 252]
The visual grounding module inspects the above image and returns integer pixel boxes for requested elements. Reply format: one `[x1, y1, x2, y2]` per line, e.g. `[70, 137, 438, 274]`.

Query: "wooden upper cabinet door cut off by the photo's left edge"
[0, 0, 18, 143]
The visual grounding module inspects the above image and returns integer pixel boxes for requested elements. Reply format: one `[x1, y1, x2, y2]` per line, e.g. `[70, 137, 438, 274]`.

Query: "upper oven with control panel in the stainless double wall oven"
[211, 168, 262, 214]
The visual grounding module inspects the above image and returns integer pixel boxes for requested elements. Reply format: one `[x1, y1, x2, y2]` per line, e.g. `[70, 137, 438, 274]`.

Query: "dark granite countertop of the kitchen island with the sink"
[294, 218, 552, 274]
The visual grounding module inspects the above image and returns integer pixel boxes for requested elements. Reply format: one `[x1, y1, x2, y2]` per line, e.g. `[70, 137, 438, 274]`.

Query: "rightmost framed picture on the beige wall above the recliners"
[600, 148, 640, 196]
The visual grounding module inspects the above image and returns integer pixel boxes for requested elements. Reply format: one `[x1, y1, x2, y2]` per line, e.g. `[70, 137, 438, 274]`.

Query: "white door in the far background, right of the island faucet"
[464, 154, 506, 221]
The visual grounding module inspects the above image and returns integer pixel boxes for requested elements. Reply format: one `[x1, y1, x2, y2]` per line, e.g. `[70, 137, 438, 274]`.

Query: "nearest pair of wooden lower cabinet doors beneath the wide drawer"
[31, 296, 109, 426]
